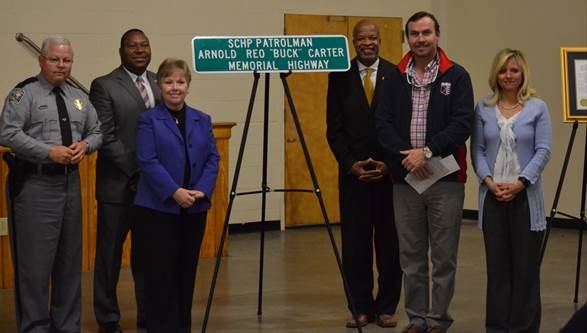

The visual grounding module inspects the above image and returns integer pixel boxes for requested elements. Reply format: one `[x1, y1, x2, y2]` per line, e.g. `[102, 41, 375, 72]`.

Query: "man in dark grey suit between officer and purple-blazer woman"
[90, 29, 161, 333]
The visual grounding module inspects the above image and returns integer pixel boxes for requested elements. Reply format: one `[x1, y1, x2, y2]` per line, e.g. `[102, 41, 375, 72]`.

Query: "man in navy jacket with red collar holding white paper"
[376, 12, 474, 333]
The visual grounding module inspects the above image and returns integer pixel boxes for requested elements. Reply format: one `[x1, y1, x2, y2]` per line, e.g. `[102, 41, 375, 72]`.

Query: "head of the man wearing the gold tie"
[353, 20, 381, 66]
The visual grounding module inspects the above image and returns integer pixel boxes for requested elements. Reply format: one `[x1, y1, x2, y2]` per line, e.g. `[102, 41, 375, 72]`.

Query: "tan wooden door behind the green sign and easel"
[284, 14, 402, 228]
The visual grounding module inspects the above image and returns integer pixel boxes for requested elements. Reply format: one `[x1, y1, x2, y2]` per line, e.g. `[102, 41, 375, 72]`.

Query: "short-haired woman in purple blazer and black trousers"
[135, 59, 219, 333]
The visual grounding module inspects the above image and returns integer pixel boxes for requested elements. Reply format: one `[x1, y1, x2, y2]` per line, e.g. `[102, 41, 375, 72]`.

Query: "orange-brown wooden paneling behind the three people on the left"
[0, 122, 235, 288]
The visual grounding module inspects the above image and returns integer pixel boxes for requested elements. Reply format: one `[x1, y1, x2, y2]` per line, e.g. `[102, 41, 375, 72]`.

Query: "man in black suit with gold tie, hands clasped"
[326, 20, 402, 327]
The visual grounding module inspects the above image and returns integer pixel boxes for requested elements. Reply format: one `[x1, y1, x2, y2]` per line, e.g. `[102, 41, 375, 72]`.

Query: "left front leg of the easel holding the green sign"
[202, 73, 260, 333]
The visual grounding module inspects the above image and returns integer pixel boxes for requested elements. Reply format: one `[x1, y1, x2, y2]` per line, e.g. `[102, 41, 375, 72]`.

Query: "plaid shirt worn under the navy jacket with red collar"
[406, 52, 440, 148]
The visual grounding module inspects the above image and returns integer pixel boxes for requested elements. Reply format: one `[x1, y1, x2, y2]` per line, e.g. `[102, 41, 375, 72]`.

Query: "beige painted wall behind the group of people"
[0, 0, 587, 222]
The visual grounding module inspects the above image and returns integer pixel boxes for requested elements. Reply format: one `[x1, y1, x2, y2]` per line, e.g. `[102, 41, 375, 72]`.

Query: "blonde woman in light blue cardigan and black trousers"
[471, 49, 552, 333]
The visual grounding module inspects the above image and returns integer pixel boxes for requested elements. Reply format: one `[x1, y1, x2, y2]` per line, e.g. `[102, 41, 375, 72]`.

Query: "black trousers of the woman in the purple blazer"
[135, 207, 206, 333]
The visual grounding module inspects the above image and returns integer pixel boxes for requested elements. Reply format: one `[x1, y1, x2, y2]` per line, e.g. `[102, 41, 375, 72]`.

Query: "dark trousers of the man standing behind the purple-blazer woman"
[94, 202, 146, 330]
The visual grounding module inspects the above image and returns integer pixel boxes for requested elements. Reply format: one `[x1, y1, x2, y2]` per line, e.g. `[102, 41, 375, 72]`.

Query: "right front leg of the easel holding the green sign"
[280, 73, 363, 333]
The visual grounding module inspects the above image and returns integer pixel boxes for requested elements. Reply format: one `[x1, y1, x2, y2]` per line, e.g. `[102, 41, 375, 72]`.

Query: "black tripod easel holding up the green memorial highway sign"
[202, 72, 363, 333]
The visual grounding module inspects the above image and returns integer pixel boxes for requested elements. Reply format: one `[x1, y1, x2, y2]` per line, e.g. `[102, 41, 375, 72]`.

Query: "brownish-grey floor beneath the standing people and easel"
[0, 222, 587, 333]
